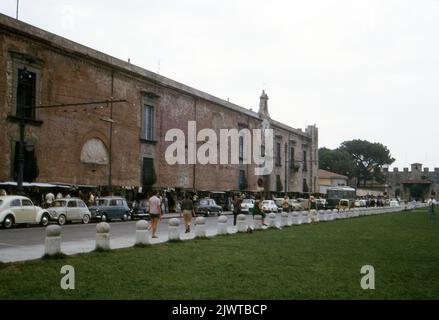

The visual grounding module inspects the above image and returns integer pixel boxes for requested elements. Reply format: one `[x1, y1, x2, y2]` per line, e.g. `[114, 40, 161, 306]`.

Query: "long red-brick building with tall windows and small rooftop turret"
[0, 14, 319, 193]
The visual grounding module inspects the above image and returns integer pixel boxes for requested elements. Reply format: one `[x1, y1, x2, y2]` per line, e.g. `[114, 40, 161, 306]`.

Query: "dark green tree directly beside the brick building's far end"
[319, 148, 355, 178]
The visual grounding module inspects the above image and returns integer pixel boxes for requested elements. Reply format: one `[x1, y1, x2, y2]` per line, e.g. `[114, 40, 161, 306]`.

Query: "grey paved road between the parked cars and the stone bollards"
[0, 215, 279, 262]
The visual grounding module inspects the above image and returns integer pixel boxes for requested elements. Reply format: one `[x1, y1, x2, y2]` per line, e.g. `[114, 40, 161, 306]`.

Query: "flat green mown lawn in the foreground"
[0, 209, 439, 300]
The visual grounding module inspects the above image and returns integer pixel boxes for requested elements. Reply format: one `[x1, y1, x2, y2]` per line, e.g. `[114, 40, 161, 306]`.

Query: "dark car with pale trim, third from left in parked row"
[90, 197, 131, 221]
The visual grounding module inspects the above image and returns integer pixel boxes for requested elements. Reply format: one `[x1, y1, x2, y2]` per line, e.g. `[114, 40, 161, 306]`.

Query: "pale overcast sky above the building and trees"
[0, 0, 439, 169]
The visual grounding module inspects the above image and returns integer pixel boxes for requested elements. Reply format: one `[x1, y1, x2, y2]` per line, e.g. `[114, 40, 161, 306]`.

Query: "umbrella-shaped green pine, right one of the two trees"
[339, 139, 395, 186]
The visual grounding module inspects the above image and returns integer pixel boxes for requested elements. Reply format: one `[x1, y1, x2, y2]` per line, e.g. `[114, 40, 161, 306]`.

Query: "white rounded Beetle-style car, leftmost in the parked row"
[0, 196, 50, 229]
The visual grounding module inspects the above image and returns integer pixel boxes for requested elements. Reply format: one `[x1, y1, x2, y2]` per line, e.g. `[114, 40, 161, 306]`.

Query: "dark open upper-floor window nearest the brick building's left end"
[16, 68, 37, 119]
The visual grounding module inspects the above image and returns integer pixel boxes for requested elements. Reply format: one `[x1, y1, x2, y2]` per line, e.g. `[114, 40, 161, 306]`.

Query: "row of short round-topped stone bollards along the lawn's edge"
[45, 207, 412, 256]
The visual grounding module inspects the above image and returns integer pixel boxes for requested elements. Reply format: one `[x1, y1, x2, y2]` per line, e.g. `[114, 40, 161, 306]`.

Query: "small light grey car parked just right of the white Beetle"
[47, 198, 91, 226]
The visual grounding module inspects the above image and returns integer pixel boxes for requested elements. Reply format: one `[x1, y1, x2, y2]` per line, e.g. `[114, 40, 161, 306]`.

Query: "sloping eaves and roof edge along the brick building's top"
[0, 13, 310, 138]
